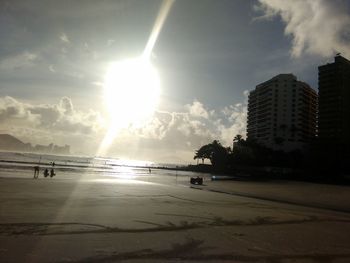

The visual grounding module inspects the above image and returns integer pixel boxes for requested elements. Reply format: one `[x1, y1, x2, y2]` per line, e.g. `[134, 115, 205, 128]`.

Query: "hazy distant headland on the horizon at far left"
[0, 134, 70, 154]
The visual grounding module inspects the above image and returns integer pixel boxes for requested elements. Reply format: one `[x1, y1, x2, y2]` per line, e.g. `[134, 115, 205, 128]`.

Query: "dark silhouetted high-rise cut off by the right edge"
[318, 55, 350, 148]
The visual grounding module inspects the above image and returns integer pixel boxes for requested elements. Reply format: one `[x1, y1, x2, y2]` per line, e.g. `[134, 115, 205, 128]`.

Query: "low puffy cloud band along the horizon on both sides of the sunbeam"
[0, 94, 246, 162]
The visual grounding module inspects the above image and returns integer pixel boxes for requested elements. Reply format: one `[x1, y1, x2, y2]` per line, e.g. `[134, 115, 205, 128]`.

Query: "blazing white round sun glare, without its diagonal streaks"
[104, 57, 160, 129]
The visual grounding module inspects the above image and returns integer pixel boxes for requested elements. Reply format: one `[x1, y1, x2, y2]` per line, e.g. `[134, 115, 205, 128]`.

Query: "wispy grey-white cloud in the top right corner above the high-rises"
[255, 0, 350, 57]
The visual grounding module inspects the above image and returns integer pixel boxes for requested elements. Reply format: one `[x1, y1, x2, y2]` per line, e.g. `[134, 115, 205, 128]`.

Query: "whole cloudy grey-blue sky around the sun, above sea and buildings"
[0, 0, 350, 164]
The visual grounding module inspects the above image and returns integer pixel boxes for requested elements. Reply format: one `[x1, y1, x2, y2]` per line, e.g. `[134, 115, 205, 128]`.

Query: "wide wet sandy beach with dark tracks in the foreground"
[0, 166, 350, 262]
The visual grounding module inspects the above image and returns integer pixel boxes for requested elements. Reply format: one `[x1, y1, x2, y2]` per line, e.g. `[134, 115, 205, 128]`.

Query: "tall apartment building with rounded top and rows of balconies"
[247, 74, 317, 151]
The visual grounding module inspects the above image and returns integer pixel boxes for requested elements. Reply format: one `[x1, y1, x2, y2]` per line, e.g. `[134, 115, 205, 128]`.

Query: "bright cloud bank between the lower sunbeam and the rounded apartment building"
[102, 92, 247, 163]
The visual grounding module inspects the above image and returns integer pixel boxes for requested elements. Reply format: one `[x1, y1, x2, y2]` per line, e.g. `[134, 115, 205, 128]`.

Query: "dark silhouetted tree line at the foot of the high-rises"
[194, 134, 349, 182]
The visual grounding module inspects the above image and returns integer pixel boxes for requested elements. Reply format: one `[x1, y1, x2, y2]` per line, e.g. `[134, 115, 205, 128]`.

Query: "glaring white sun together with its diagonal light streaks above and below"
[97, 0, 175, 156]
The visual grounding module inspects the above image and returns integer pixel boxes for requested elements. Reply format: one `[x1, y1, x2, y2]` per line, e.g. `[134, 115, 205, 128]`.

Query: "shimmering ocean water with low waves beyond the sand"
[0, 152, 208, 183]
